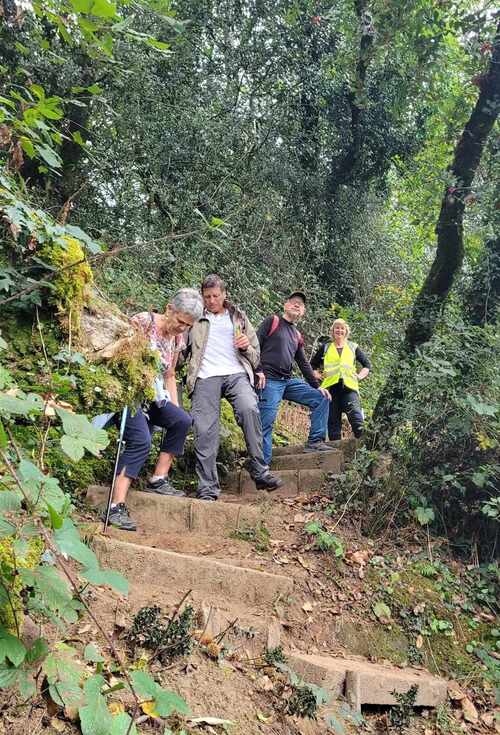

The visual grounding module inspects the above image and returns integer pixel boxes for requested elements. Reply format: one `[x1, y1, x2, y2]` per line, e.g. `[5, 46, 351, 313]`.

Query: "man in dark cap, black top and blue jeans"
[256, 291, 332, 465]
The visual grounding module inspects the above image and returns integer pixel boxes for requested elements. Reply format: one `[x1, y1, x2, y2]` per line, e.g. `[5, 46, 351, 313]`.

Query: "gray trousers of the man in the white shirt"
[191, 373, 268, 498]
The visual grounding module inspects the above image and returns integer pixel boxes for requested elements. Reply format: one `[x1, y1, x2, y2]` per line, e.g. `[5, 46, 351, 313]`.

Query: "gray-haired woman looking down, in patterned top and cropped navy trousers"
[108, 288, 203, 531]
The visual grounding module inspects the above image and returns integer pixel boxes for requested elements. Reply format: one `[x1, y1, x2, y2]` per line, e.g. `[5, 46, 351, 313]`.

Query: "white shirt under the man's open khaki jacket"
[198, 309, 245, 379]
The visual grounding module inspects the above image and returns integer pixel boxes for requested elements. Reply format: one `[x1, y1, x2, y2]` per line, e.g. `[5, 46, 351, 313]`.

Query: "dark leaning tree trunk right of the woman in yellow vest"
[374, 23, 500, 436]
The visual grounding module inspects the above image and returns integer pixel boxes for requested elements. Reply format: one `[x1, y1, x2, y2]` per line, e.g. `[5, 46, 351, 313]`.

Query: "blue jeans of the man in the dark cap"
[259, 378, 330, 465]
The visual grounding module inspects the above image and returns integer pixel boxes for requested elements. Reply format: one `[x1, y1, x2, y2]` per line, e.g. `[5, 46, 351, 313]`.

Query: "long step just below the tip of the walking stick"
[93, 535, 293, 612]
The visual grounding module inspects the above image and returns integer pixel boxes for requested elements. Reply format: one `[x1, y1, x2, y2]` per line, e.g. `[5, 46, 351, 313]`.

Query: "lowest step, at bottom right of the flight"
[289, 654, 447, 711]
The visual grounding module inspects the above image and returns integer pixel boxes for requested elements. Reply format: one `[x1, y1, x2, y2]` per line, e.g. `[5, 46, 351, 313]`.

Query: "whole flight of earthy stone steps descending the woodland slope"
[87, 442, 446, 710]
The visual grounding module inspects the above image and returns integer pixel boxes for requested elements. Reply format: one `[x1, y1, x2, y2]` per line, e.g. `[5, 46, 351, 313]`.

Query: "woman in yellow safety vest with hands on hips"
[311, 319, 371, 439]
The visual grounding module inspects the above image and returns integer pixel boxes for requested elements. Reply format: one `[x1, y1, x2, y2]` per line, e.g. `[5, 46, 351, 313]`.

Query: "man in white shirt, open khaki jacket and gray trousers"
[187, 274, 282, 500]
